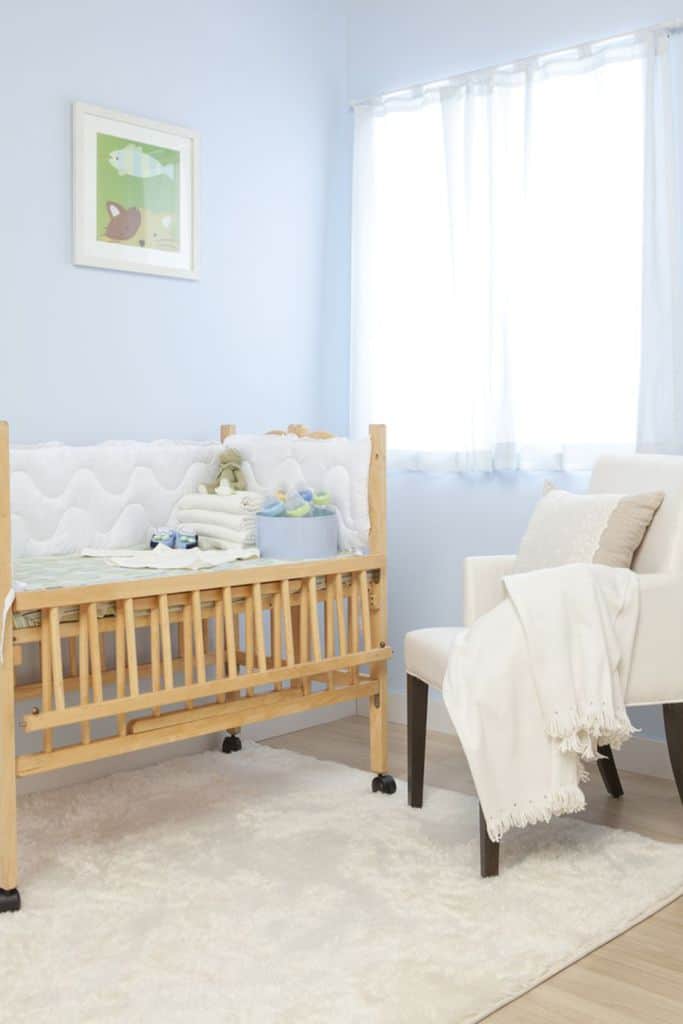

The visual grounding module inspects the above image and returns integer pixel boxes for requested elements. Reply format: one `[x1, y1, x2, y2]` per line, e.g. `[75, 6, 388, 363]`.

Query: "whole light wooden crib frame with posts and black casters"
[0, 423, 395, 911]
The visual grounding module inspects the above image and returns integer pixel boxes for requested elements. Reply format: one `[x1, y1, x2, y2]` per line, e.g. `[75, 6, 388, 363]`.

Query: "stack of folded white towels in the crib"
[174, 490, 263, 550]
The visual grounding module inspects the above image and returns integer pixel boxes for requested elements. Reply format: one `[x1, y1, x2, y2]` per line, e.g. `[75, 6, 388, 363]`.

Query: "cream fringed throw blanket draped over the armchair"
[443, 564, 639, 842]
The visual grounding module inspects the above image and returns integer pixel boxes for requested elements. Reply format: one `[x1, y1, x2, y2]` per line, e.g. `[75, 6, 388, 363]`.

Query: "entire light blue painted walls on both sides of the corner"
[0, 0, 671, 745]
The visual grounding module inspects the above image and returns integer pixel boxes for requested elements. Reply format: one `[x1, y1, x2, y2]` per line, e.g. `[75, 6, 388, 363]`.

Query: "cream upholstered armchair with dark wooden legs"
[405, 455, 683, 877]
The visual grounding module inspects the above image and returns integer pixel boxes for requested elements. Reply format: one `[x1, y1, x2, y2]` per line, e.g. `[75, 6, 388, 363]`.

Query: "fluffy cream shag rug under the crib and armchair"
[0, 743, 683, 1024]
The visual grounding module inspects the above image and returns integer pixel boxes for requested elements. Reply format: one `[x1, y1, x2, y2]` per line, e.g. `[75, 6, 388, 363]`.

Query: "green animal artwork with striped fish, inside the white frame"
[97, 133, 180, 252]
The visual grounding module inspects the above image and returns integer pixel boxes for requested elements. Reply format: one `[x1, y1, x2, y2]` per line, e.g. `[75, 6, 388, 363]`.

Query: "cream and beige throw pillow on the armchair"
[514, 483, 664, 572]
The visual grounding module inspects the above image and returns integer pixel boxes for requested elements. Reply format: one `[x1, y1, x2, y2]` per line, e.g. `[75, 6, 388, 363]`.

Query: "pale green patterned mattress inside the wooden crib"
[13, 554, 368, 629]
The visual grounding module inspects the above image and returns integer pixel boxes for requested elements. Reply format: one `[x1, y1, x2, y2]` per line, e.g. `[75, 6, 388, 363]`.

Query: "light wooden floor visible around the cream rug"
[267, 716, 683, 1024]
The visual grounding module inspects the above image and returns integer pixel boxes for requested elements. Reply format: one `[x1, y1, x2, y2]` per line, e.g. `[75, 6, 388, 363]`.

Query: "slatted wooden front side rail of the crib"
[15, 557, 391, 775]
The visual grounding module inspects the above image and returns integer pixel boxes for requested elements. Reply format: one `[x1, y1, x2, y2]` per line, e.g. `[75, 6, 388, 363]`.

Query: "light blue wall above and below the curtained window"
[348, 0, 683, 738]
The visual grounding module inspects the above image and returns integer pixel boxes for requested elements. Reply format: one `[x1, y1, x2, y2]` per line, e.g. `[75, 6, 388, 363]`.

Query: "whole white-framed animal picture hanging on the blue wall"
[74, 102, 200, 279]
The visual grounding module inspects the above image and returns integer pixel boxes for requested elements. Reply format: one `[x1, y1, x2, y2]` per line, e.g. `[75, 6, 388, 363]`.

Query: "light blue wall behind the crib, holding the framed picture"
[0, 0, 350, 441]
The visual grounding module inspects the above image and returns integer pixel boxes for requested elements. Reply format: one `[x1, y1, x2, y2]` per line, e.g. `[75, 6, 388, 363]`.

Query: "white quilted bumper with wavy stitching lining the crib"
[10, 434, 370, 557]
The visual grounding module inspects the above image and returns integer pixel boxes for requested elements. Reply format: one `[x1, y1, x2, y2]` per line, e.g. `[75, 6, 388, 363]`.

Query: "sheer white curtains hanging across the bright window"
[351, 31, 671, 470]
